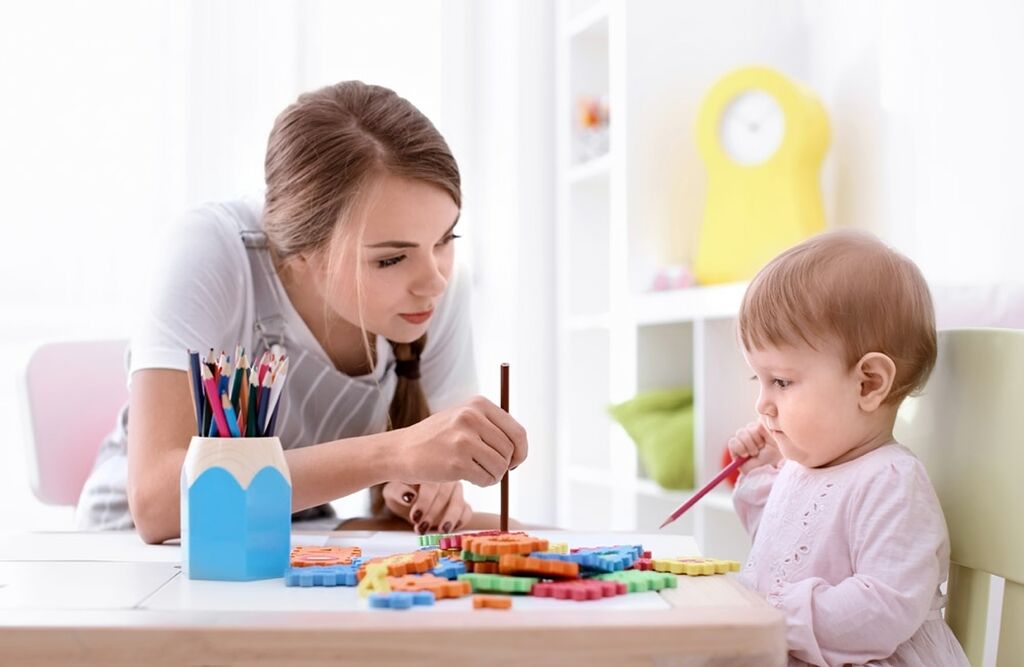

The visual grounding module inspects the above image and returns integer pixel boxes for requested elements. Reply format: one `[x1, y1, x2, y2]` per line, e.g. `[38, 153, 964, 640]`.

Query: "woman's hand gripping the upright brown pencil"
[399, 397, 528, 487]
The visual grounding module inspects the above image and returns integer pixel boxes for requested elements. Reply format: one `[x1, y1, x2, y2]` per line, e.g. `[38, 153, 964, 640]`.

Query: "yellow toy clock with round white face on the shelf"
[694, 67, 828, 284]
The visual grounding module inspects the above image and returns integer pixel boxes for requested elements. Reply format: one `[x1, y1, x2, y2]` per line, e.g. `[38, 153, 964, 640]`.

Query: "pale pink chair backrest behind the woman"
[25, 340, 128, 505]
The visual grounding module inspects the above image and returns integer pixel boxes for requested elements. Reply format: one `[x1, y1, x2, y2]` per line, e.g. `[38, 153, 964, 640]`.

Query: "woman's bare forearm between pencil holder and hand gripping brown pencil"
[285, 431, 401, 511]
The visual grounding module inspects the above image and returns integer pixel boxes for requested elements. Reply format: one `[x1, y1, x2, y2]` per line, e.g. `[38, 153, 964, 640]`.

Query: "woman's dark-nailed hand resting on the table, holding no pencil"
[384, 482, 473, 535]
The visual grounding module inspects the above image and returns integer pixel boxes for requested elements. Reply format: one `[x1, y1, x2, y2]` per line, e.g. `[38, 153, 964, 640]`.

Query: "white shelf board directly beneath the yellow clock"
[632, 283, 746, 326]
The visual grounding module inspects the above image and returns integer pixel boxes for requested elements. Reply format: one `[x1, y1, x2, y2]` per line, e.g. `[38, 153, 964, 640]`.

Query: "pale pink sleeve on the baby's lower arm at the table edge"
[768, 459, 949, 665]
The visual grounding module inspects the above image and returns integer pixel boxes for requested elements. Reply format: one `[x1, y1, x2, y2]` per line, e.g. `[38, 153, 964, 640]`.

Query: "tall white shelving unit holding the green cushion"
[555, 0, 756, 559]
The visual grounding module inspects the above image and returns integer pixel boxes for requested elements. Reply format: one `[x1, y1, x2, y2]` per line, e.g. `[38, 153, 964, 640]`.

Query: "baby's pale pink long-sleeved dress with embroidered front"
[733, 443, 968, 667]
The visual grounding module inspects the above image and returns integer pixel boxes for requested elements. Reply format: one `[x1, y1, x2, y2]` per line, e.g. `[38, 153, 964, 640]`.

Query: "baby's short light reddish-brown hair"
[738, 230, 936, 405]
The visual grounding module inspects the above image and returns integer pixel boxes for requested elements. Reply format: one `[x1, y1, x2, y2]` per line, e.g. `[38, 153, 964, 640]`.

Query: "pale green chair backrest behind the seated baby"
[895, 329, 1024, 665]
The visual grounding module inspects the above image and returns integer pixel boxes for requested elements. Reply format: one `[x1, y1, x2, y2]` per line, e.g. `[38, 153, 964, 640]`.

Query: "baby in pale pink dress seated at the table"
[729, 232, 968, 667]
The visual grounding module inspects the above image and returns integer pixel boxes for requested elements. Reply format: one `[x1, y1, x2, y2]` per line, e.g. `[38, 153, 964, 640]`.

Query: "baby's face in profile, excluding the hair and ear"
[743, 344, 868, 468]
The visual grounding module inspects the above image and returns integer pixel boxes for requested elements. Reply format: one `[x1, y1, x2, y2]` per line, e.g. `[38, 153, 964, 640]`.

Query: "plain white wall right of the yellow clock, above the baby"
[803, 0, 1024, 283]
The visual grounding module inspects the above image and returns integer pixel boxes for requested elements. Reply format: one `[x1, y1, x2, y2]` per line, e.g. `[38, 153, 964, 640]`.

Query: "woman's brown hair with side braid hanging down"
[263, 81, 462, 513]
